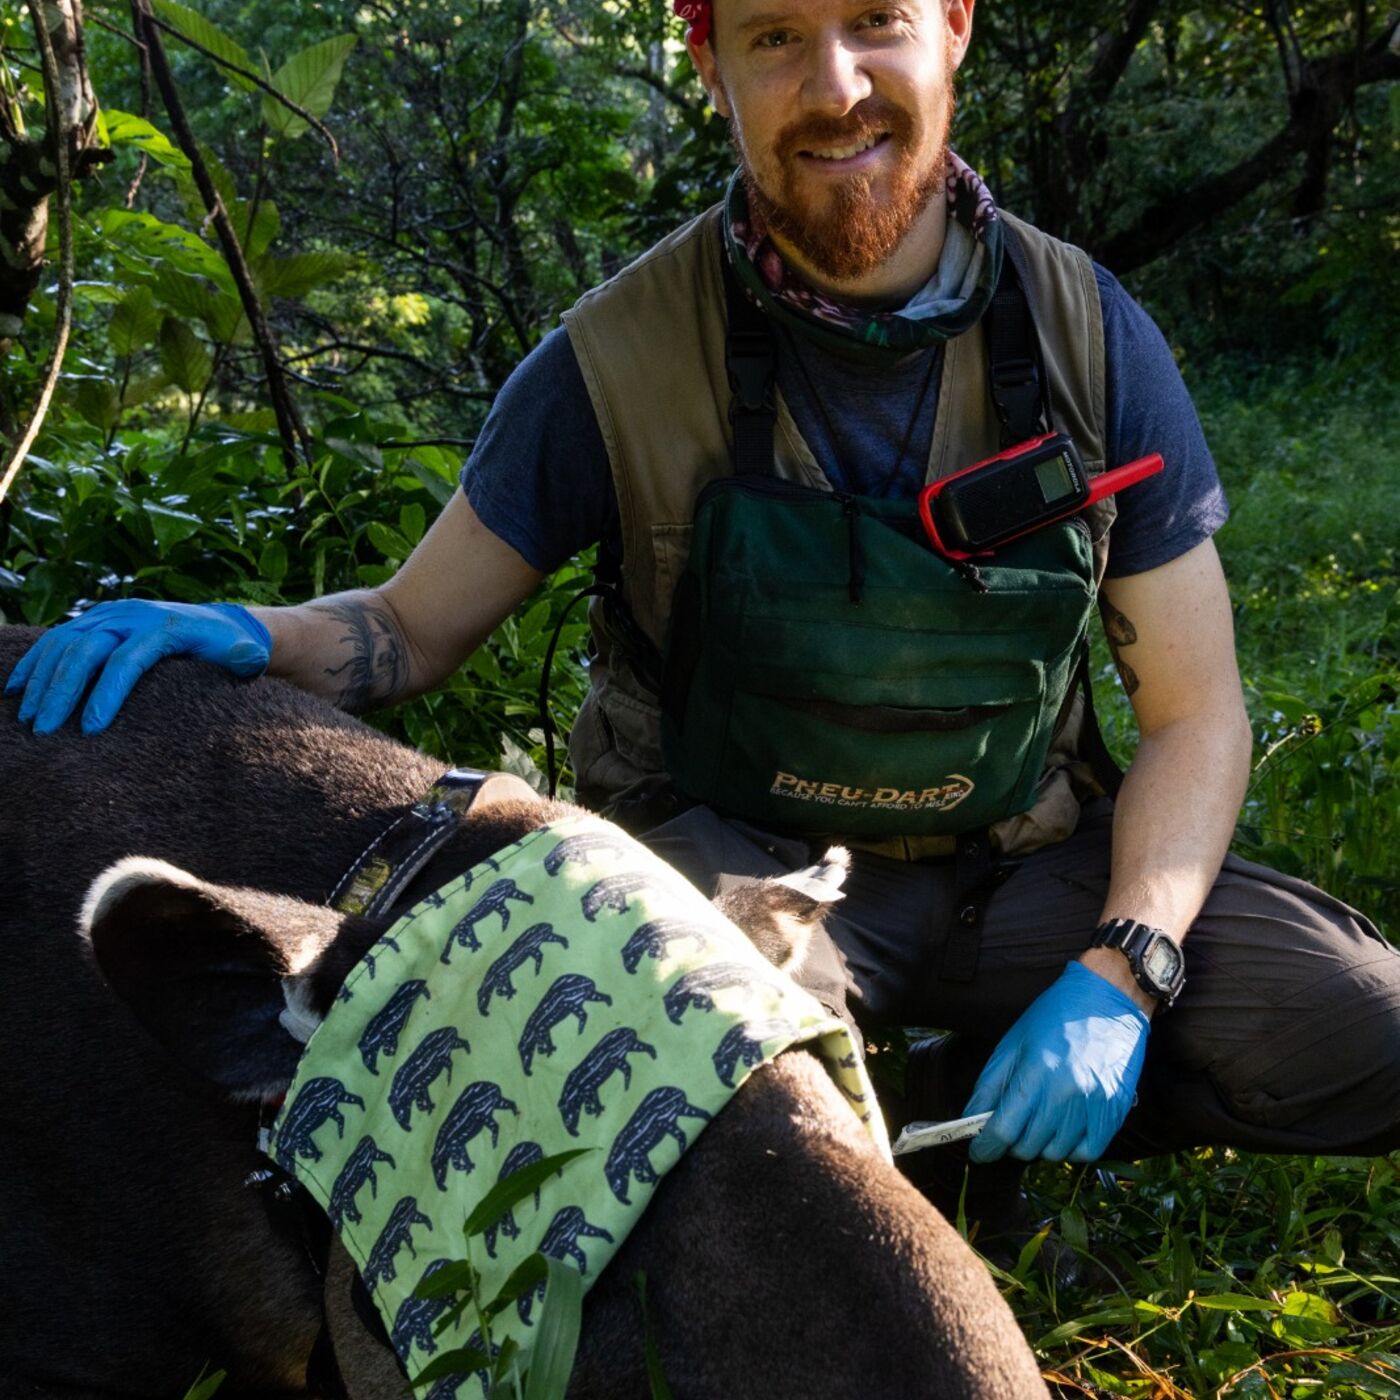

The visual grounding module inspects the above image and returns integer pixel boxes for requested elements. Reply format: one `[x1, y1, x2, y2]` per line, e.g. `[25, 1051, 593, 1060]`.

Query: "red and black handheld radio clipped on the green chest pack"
[918, 433, 1163, 560]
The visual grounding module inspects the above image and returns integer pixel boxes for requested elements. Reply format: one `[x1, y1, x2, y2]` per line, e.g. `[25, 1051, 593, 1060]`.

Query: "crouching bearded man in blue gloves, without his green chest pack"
[7, 0, 1400, 1198]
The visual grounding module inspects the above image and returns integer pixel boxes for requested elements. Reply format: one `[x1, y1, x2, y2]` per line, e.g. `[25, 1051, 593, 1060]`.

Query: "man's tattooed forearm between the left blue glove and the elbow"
[251, 589, 425, 714]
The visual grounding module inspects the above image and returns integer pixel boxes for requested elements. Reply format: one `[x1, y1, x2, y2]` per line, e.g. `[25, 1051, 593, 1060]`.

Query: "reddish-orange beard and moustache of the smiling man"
[731, 84, 953, 283]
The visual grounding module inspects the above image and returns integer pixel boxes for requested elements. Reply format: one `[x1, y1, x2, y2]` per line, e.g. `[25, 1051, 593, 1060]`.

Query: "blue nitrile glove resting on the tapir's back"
[4, 598, 272, 734]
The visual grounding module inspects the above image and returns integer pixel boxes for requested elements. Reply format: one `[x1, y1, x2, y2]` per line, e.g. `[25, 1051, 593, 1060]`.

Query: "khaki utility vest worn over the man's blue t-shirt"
[563, 206, 1114, 860]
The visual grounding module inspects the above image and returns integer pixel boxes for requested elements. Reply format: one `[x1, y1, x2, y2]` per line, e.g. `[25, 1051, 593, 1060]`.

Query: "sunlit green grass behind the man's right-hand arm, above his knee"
[1095, 361, 1400, 937]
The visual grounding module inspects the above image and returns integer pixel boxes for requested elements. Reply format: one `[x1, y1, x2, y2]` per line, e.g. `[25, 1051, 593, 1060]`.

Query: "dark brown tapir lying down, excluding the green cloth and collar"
[0, 627, 1047, 1400]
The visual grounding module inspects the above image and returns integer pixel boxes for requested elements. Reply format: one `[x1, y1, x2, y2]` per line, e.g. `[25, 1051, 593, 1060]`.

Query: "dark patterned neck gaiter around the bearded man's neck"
[724, 151, 1005, 361]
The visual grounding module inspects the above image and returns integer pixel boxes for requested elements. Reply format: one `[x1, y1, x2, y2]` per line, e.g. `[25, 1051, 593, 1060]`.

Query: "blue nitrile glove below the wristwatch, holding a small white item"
[963, 962, 1151, 1162]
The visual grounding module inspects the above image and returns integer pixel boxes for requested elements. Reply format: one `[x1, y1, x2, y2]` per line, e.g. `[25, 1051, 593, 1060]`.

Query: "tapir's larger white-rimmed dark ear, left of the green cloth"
[81, 857, 358, 1098]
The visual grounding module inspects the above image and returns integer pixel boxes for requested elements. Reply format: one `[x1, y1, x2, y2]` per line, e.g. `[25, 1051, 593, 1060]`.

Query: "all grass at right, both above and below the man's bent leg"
[1019, 367, 1400, 1400]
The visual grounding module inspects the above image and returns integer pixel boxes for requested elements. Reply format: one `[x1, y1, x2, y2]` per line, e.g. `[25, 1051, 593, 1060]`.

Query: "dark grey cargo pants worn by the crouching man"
[643, 799, 1400, 1159]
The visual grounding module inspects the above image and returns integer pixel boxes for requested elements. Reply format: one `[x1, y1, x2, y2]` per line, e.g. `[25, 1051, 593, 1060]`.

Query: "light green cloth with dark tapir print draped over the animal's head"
[270, 818, 888, 1396]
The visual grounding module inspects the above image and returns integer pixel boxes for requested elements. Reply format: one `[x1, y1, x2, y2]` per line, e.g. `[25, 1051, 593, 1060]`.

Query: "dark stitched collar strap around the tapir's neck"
[326, 769, 538, 917]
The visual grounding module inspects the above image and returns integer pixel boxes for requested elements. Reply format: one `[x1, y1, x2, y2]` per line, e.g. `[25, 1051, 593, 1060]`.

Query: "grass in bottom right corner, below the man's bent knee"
[997, 1149, 1400, 1400]
